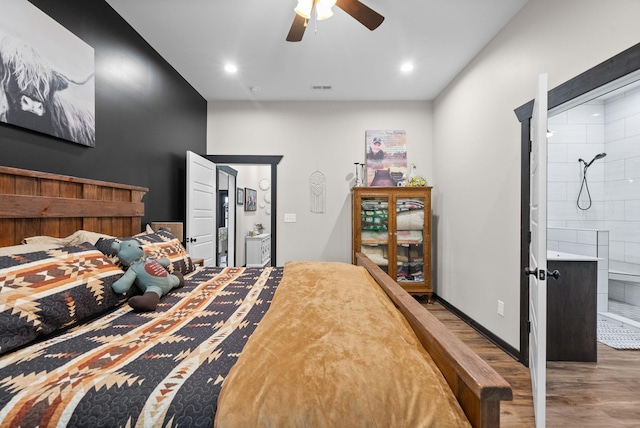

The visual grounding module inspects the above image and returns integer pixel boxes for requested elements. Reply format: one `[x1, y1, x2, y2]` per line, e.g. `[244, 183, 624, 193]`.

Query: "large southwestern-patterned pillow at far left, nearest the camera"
[0, 242, 132, 354]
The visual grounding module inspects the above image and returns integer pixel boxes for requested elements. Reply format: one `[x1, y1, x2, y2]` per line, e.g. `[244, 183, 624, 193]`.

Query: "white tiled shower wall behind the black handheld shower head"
[548, 88, 640, 305]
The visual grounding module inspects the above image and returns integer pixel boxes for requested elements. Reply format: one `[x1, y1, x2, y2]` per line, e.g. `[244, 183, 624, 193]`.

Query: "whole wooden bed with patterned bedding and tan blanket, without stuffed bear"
[0, 167, 512, 428]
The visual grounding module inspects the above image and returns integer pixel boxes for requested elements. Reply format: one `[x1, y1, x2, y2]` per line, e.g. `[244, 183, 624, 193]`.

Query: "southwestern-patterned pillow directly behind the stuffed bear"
[96, 230, 195, 275]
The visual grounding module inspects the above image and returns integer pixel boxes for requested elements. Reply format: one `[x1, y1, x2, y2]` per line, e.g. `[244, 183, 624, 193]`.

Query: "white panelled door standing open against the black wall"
[185, 151, 218, 266]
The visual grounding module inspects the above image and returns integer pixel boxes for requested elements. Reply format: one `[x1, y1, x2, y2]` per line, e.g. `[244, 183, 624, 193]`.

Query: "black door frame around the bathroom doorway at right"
[514, 43, 640, 367]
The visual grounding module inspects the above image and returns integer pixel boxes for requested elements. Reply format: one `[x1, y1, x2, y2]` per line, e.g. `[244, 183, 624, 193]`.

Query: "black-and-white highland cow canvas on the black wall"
[0, 1, 95, 147]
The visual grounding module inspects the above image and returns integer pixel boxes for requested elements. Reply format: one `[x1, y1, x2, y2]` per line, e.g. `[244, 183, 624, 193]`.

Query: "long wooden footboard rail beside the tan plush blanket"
[356, 253, 513, 428]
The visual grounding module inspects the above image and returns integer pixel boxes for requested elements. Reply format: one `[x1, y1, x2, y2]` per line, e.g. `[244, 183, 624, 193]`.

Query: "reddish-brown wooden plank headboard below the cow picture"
[0, 166, 148, 247]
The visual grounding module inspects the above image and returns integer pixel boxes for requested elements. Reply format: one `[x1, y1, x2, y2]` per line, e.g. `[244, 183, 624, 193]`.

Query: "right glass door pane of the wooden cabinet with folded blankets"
[395, 197, 424, 283]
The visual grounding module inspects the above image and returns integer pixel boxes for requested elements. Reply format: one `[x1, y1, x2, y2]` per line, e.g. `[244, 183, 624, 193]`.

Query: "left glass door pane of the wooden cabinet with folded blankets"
[359, 197, 394, 273]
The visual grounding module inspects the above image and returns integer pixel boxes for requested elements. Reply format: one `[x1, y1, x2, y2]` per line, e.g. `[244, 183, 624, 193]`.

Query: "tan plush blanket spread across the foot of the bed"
[216, 262, 468, 428]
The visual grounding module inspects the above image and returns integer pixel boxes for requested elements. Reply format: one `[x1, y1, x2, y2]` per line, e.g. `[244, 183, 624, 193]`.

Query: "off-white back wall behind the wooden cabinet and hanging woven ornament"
[207, 101, 433, 266]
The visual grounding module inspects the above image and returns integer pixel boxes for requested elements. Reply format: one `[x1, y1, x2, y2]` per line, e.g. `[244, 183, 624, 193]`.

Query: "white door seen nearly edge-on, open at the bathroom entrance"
[529, 73, 547, 428]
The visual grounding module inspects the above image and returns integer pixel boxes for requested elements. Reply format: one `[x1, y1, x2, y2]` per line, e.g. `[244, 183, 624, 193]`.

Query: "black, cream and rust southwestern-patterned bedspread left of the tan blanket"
[0, 267, 283, 427]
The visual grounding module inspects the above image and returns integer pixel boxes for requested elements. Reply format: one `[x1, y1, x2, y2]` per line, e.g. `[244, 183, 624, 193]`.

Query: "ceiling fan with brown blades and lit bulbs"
[287, 0, 384, 42]
